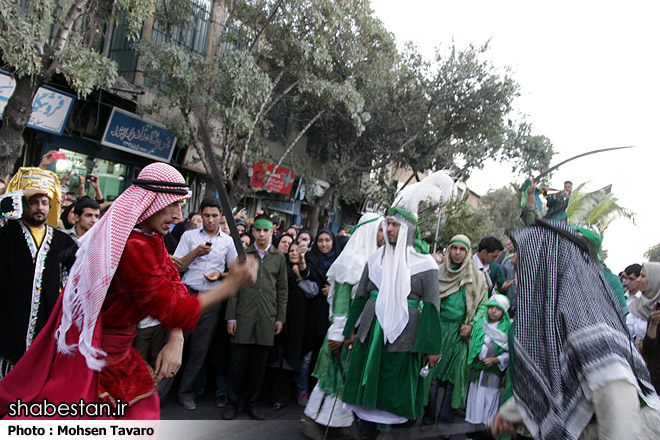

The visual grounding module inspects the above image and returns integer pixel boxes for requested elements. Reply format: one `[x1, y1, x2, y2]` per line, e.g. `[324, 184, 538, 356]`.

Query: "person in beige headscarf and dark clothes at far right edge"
[630, 262, 660, 393]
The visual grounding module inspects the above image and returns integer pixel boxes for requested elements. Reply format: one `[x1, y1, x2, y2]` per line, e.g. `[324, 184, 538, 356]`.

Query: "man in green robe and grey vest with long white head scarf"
[342, 207, 441, 439]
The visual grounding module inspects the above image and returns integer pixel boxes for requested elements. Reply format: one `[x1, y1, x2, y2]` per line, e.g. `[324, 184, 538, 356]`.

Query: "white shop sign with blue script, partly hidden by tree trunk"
[0, 70, 76, 134]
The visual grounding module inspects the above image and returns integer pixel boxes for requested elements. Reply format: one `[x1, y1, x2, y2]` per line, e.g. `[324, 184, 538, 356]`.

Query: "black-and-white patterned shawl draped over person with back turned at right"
[512, 221, 660, 440]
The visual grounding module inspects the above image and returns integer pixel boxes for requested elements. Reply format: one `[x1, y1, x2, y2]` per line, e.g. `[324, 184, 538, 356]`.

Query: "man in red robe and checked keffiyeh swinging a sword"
[0, 163, 256, 419]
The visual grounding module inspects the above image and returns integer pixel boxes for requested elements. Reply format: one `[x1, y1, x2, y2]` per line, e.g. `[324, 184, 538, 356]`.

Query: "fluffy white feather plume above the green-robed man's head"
[393, 170, 455, 217]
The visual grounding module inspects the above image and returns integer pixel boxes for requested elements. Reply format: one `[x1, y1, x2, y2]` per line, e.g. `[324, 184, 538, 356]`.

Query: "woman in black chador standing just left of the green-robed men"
[298, 229, 339, 406]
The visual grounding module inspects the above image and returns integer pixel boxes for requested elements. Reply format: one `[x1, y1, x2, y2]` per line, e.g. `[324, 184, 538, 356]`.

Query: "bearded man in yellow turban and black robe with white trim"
[0, 168, 75, 379]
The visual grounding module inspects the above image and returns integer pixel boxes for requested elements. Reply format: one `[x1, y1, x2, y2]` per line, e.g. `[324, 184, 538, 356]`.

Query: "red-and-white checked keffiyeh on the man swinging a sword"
[55, 163, 189, 371]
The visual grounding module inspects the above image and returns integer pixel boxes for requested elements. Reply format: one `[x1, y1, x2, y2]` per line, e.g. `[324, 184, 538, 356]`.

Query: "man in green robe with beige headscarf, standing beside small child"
[422, 234, 488, 434]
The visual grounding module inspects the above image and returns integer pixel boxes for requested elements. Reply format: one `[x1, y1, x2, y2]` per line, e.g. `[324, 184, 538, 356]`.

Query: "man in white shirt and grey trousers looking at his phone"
[173, 197, 237, 411]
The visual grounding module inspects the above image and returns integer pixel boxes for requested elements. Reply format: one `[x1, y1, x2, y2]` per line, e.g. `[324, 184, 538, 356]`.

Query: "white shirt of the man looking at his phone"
[174, 227, 237, 292]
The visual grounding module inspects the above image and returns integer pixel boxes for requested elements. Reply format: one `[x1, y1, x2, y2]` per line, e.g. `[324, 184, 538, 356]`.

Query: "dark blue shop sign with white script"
[101, 107, 176, 162]
